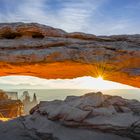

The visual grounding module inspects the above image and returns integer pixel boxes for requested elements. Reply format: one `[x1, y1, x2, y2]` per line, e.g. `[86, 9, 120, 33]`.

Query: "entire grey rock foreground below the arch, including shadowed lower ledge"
[0, 92, 140, 140]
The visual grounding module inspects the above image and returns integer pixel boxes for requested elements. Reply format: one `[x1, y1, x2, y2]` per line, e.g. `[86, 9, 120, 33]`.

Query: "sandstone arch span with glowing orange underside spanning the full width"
[0, 23, 140, 87]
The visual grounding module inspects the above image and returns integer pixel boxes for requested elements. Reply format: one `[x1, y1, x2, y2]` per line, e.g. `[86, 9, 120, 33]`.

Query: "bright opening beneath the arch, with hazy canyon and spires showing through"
[0, 75, 140, 121]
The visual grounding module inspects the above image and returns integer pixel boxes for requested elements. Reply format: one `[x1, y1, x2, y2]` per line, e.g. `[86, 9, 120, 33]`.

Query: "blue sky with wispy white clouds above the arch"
[0, 0, 140, 35]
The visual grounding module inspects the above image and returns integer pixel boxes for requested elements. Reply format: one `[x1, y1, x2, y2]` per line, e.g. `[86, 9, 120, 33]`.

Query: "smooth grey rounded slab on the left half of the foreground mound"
[39, 101, 90, 122]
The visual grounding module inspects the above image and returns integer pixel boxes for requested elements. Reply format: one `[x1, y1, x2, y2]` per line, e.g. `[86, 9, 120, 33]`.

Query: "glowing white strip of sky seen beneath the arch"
[0, 75, 134, 90]
